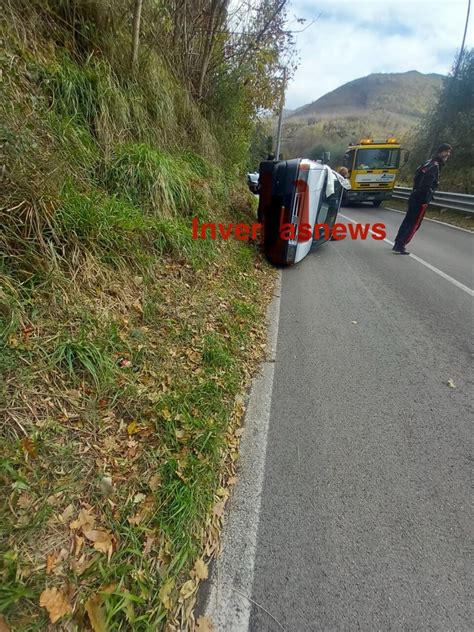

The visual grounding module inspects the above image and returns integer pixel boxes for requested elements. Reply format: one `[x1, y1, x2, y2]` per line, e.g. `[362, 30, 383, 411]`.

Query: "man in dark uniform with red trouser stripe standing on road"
[392, 143, 452, 255]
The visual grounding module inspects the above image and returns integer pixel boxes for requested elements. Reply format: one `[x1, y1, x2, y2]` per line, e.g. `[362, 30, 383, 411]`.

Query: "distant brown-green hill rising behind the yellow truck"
[283, 71, 443, 160]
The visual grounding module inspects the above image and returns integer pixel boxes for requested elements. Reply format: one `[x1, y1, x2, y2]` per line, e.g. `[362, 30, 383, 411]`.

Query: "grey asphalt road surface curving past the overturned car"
[244, 207, 474, 632]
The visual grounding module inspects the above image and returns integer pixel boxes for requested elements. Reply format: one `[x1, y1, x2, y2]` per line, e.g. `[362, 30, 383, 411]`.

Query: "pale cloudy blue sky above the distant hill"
[285, 0, 474, 109]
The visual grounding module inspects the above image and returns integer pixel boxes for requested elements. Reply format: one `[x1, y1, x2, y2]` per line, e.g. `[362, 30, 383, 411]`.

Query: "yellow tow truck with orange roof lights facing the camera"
[343, 136, 408, 207]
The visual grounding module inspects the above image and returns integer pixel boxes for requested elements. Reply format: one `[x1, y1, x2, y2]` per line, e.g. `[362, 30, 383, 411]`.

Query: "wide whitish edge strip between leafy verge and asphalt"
[205, 272, 281, 632]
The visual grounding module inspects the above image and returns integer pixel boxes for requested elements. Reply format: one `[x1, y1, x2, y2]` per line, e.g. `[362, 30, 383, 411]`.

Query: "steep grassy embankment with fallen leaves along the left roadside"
[0, 9, 273, 632]
